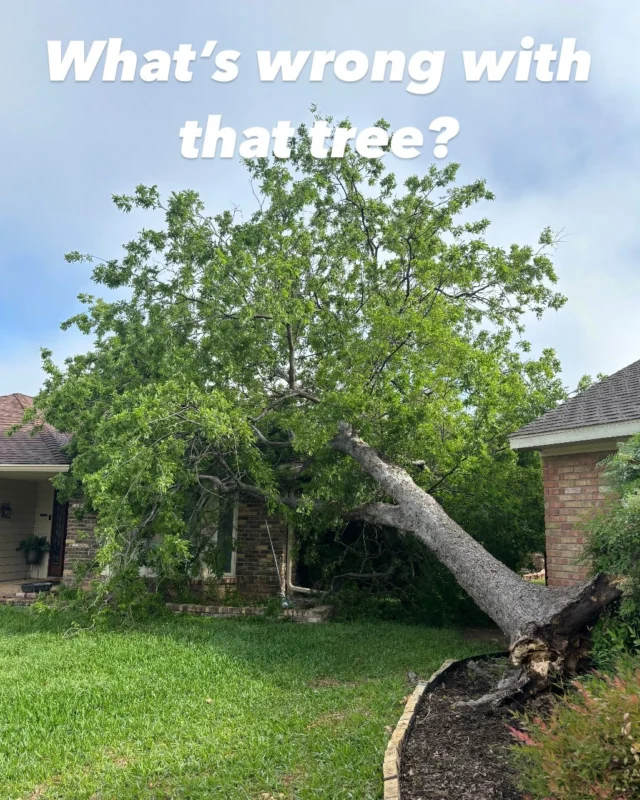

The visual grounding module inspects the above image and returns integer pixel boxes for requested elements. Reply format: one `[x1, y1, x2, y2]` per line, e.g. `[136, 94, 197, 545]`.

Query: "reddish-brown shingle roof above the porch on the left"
[0, 394, 69, 466]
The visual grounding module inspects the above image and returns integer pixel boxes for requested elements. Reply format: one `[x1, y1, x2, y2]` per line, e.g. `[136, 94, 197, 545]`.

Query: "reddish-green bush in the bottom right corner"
[512, 665, 640, 800]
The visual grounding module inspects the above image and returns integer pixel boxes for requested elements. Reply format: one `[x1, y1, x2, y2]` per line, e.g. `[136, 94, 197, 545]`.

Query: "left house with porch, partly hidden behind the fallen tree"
[0, 394, 294, 598]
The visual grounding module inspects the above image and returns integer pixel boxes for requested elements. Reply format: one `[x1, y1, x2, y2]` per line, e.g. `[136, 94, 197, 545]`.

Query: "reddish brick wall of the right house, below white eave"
[542, 452, 609, 586]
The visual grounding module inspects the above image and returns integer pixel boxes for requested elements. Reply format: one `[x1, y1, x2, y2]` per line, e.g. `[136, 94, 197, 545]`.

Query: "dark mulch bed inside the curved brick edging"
[401, 659, 523, 800]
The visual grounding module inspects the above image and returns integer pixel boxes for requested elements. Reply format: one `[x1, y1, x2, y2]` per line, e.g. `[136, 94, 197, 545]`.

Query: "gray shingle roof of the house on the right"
[512, 361, 640, 438]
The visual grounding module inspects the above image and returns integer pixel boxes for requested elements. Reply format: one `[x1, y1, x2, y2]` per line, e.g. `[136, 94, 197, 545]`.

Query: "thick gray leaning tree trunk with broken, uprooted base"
[331, 425, 620, 696]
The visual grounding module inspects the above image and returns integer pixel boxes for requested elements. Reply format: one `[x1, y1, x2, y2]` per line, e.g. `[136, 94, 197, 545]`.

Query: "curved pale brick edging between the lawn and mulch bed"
[382, 650, 509, 800]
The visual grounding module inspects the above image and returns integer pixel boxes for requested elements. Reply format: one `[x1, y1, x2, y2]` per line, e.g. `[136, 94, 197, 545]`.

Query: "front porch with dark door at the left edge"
[0, 466, 68, 596]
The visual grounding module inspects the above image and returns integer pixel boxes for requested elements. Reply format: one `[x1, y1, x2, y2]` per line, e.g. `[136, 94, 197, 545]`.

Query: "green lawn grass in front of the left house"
[0, 607, 490, 800]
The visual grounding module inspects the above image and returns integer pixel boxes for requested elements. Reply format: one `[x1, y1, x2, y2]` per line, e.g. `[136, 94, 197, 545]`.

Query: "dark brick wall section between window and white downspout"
[236, 501, 287, 598]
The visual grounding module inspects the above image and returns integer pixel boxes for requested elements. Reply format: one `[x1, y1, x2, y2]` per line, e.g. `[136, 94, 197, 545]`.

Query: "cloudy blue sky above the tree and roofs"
[0, 0, 640, 394]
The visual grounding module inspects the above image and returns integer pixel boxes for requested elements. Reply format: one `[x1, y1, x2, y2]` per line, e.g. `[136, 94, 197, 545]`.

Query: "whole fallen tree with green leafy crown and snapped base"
[34, 114, 617, 691]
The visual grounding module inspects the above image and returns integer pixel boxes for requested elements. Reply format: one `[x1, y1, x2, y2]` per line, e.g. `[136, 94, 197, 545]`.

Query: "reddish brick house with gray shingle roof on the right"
[509, 361, 640, 586]
